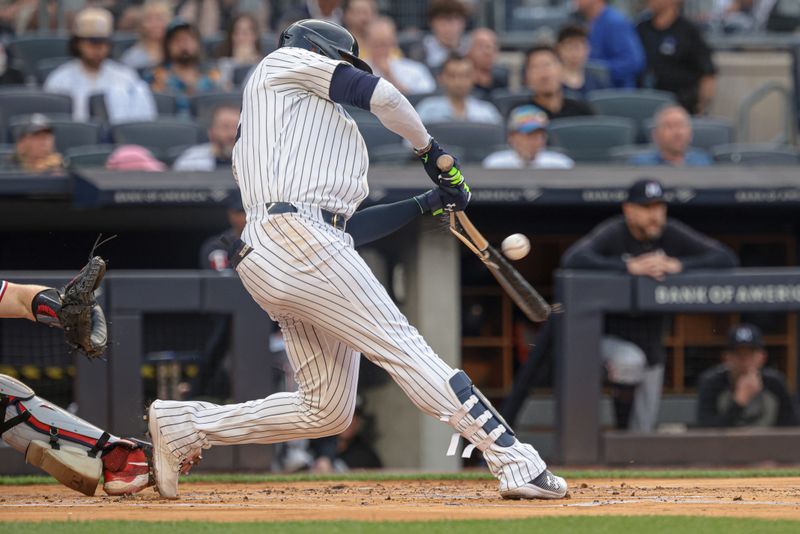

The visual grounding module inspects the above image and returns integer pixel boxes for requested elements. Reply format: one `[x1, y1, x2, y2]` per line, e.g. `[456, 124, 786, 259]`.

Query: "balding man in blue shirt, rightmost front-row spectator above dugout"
[628, 104, 712, 167]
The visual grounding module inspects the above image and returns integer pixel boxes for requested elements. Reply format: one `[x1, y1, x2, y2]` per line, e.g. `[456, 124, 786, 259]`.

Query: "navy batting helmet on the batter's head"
[278, 19, 372, 74]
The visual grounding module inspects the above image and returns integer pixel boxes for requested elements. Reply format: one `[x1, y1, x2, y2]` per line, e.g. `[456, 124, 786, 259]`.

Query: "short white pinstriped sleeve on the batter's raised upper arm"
[264, 47, 345, 100]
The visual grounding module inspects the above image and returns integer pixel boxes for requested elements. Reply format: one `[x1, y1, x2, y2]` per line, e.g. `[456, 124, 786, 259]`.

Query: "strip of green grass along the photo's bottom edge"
[0, 516, 798, 534]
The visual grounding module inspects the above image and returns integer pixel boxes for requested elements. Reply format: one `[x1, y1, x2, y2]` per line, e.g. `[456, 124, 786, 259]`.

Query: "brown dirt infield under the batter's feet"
[0, 478, 800, 522]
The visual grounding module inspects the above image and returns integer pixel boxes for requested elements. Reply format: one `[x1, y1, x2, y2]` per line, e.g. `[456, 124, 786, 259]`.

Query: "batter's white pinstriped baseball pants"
[158, 212, 545, 491]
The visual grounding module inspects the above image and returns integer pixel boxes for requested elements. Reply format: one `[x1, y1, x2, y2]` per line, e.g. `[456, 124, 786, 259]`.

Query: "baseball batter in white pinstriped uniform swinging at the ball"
[148, 20, 567, 499]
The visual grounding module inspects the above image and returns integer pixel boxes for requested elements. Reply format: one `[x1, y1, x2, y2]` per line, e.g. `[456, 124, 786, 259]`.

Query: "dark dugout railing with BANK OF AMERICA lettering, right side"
[553, 268, 800, 465]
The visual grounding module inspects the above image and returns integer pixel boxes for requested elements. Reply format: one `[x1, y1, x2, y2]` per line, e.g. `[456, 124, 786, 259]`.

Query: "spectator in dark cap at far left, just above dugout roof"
[4, 113, 64, 174]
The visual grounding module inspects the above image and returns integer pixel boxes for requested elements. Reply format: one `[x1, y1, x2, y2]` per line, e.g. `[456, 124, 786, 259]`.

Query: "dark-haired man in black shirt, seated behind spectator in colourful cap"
[525, 45, 593, 121]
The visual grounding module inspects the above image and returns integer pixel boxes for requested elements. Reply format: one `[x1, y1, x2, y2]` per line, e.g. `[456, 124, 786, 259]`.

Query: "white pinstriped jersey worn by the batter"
[233, 48, 369, 218]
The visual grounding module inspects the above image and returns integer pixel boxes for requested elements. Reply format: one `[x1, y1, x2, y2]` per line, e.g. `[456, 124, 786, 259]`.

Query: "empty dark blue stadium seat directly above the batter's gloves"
[425, 121, 506, 163]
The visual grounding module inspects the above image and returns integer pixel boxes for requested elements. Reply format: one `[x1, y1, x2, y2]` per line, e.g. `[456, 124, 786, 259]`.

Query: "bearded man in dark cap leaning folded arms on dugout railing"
[561, 178, 737, 432]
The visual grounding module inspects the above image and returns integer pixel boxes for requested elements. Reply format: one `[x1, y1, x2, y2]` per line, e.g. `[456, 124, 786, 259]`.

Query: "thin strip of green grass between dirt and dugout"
[0, 467, 800, 486]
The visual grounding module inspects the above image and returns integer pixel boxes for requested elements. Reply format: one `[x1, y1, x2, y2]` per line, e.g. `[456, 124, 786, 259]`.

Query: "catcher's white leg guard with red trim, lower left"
[0, 374, 112, 495]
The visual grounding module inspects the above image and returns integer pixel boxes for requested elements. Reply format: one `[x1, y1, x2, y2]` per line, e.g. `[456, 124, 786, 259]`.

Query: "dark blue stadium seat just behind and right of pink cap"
[111, 118, 199, 159]
